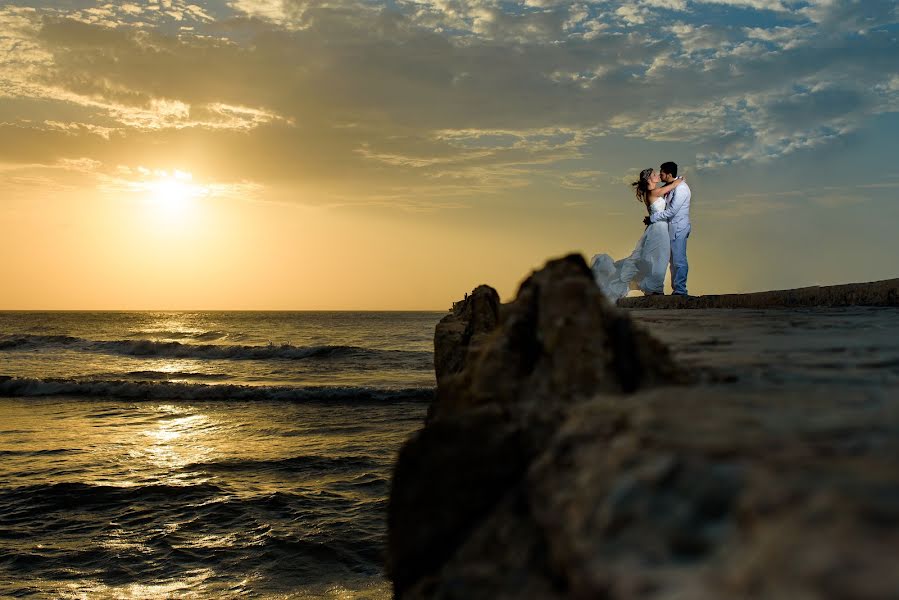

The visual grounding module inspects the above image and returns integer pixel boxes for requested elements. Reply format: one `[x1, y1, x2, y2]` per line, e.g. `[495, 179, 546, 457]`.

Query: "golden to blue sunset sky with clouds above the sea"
[0, 0, 899, 310]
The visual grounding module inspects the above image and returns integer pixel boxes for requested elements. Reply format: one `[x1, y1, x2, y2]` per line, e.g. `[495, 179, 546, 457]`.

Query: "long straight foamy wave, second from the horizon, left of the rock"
[0, 375, 434, 404]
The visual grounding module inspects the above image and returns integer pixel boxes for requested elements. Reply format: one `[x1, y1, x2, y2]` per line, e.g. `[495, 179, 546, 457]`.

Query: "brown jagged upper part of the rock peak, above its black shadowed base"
[430, 255, 686, 418]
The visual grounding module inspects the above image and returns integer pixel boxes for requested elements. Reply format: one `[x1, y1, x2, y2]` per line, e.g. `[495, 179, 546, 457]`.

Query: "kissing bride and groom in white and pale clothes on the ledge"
[592, 162, 691, 302]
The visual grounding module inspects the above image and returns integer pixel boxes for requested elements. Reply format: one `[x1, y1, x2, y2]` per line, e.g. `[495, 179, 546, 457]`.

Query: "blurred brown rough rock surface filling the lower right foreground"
[418, 389, 899, 600]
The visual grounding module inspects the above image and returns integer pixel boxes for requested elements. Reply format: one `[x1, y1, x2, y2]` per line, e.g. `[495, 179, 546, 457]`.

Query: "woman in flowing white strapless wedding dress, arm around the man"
[592, 169, 685, 302]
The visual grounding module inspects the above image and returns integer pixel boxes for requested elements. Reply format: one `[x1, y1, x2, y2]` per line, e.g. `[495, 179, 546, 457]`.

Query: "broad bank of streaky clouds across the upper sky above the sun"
[0, 0, 899, 206]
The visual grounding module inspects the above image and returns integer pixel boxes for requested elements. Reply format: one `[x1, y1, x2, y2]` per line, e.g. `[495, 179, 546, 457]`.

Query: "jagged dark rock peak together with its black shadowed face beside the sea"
[388, 255, 685, 595]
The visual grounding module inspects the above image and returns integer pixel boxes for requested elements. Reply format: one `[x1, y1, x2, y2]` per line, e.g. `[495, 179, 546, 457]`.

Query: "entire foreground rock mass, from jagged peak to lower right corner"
[388, 256, 899, 600]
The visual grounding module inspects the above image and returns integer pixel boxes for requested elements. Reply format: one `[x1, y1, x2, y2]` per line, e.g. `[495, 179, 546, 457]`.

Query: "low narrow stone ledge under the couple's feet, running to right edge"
[618, 279, 899, 309]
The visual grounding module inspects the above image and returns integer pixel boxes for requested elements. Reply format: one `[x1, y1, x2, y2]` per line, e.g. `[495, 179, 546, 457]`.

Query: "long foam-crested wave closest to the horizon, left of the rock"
[0, 335, 431, 366]
